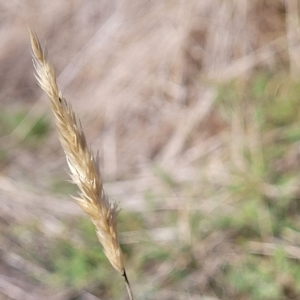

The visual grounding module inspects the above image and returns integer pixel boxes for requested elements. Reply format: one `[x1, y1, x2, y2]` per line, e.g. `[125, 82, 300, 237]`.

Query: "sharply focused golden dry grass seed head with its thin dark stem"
[29, 29, 133, 299]
